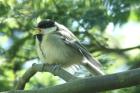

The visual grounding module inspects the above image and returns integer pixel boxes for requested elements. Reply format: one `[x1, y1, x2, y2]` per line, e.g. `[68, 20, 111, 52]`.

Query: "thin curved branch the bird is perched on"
[16, 64, 77, 90]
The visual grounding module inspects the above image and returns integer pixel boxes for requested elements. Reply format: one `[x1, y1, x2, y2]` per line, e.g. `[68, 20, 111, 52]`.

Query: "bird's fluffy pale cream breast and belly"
[35, 33, 82, 66]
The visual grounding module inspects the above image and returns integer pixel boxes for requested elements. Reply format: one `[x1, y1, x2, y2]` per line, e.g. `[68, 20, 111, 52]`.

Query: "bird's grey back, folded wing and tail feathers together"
[56, 23, 104, 75]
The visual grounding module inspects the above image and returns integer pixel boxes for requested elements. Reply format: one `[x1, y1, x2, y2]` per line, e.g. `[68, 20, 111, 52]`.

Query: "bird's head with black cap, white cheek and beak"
[34, 19, 57, 35]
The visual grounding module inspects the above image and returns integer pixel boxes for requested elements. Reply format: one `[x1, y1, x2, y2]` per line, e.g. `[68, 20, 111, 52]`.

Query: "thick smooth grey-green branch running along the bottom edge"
[0, 68, 140, 93]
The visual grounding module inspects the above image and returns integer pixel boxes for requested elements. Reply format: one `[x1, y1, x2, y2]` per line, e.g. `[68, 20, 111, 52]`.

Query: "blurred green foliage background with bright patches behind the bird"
[0, 0, 140, 93]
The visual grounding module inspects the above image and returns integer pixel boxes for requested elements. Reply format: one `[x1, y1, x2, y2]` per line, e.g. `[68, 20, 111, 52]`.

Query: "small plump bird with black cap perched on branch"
[34, 19, 104, 75]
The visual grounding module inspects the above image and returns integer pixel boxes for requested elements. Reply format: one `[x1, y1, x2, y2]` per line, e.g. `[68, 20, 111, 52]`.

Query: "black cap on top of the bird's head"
[37, 19, 55, 28]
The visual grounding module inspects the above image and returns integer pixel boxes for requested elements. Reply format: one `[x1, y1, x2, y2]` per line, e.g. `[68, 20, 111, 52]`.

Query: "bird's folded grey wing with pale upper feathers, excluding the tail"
[55, 29, 101, 68]
